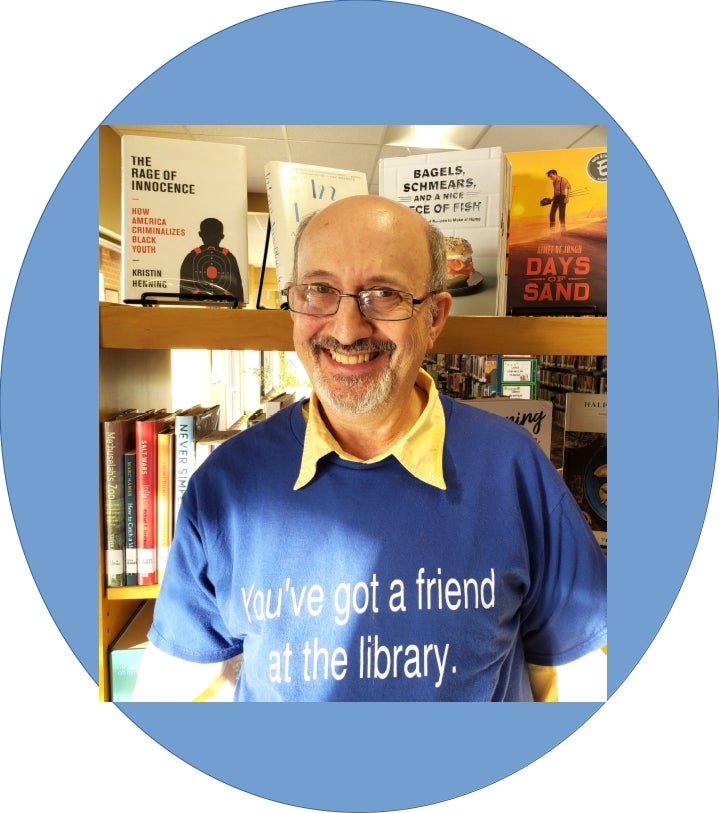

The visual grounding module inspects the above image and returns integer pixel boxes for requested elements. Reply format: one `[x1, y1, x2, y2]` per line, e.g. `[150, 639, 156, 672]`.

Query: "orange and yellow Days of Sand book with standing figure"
[506, 147, 607, 316]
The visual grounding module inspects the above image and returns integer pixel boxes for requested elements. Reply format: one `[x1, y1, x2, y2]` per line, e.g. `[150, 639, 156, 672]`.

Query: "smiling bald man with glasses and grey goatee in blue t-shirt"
[136, 196, 606, 701]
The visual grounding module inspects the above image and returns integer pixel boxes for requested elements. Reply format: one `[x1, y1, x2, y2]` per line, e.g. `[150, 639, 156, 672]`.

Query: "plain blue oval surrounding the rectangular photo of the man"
[0, 0, 717, 811]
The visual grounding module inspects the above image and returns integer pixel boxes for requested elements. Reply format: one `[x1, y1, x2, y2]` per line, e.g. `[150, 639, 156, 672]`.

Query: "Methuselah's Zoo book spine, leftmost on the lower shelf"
[100, 409, 138, 587]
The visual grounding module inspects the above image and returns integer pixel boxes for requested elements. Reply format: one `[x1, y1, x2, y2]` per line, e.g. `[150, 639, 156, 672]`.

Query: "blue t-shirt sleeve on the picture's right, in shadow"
[522, 482, 607, 666]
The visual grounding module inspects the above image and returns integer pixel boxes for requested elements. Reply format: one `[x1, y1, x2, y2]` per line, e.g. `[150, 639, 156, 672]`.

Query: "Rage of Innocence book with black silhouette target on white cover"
[121, 135, 248, 305]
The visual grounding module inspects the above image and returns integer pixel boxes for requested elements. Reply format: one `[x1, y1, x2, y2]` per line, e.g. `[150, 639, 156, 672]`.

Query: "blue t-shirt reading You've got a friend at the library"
[150, 397, 606, 701]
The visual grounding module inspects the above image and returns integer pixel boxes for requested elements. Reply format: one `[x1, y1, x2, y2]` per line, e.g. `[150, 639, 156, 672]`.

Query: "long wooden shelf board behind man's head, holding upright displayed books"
[100, 303, 607, 356]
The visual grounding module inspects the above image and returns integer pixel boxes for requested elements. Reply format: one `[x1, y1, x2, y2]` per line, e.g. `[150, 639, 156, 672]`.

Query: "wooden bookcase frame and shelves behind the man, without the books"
[98, 303, 607, 700]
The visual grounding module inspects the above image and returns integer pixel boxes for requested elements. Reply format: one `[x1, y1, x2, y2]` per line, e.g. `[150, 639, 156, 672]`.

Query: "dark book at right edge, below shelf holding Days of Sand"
[562, 392, 607, 552]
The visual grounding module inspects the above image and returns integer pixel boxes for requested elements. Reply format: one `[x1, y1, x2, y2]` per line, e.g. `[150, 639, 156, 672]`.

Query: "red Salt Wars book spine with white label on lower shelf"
[135, 412, 174, 585]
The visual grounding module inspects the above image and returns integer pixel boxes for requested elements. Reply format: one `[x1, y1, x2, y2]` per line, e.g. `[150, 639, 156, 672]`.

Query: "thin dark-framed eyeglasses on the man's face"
[282, 284, 438, 322]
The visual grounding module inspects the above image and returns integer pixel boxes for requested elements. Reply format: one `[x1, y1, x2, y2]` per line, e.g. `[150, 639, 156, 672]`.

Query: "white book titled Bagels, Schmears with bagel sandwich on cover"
[379, 147, 511, 316]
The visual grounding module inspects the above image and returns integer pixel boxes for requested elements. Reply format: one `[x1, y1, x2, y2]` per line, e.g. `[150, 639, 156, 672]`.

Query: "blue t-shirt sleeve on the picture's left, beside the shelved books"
[148, 480, 242, 663]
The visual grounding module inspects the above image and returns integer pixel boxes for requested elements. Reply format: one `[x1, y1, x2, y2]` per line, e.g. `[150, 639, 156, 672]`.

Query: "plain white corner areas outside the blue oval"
[0, 0, 719, 813]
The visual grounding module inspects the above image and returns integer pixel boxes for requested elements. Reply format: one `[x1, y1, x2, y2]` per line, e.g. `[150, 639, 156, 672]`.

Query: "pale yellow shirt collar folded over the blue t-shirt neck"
[294, 369, 447, 491]
